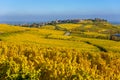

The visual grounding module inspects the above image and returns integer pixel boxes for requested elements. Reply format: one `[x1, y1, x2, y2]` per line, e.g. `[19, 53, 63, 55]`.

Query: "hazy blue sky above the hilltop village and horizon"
[0, 0, 120, 21]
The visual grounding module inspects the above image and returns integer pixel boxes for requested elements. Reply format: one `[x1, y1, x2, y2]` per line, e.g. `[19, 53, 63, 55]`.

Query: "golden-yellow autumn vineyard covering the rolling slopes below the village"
[0, 22, 120, 80]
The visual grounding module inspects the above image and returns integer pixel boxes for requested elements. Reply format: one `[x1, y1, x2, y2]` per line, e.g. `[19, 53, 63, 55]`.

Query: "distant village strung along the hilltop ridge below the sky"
[17, 18, 107, 28]
